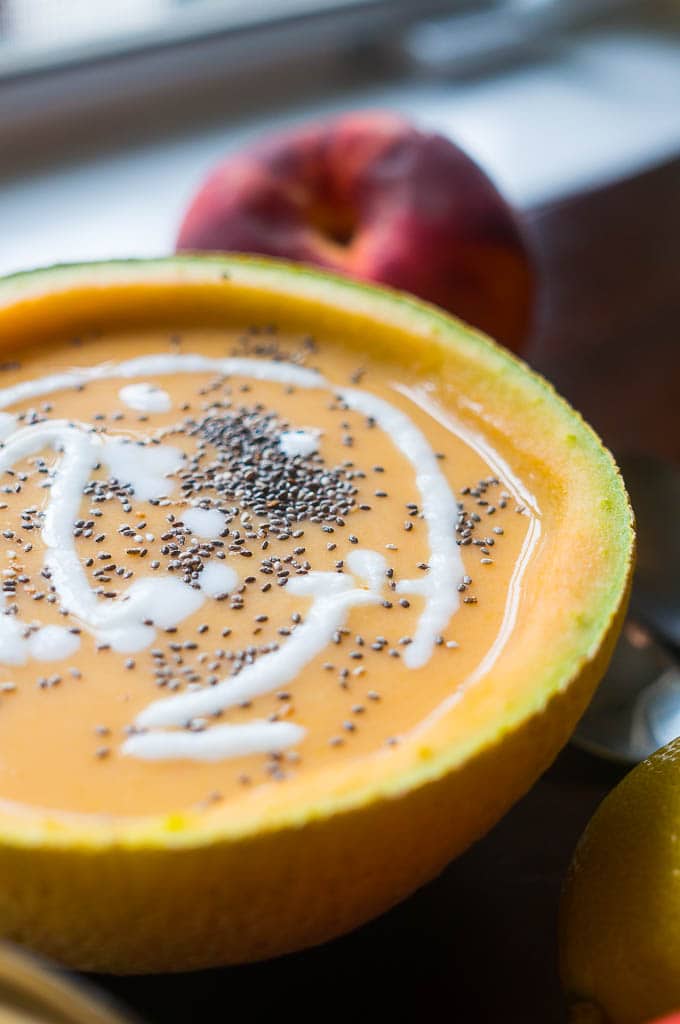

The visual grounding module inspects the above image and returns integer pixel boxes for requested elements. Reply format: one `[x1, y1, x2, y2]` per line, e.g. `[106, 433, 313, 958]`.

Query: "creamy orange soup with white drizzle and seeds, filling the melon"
[0, 326, 540, 815]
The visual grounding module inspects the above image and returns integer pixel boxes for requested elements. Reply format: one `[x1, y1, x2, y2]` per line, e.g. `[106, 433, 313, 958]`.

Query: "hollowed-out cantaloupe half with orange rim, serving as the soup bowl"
[0, 257, 634, 972]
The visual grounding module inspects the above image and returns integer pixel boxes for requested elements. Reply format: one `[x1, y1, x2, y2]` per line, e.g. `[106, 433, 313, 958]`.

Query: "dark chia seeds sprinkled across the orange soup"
[0, 348, 524, 786]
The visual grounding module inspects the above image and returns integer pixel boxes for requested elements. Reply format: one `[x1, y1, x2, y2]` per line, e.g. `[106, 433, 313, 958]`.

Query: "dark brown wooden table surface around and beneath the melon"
[90, 160, 680, 1024]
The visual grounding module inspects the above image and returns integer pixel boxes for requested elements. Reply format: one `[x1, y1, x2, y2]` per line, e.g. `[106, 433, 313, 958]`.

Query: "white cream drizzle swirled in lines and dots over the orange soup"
[0, 353, 463, 760]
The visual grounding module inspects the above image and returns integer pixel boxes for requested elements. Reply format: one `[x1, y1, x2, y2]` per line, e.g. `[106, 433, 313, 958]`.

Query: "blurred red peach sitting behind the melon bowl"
[177, 112, 533, 348]
